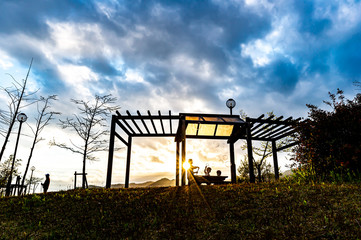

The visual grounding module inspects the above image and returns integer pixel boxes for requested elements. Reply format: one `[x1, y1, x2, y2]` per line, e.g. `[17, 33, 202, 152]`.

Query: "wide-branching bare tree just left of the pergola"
[50, 95, 119, 188]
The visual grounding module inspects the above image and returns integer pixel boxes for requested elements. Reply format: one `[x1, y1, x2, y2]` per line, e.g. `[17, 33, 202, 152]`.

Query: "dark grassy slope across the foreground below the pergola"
[0, 183, 361, 239]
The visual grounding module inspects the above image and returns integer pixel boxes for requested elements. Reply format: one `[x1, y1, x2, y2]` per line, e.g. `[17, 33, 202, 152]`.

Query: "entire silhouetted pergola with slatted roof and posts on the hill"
[106, 110, 299, 188]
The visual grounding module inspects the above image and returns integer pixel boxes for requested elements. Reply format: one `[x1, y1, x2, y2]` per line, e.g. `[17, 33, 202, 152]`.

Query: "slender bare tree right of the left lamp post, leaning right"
[19, 95, 60, 194]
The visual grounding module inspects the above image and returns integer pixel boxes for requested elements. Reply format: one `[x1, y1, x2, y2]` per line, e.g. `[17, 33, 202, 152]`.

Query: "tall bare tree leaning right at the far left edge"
[0, 59, 35, 162]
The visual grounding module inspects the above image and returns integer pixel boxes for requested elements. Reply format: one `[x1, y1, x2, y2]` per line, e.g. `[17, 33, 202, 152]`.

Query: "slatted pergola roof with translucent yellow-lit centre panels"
[115, 110, 300, 144]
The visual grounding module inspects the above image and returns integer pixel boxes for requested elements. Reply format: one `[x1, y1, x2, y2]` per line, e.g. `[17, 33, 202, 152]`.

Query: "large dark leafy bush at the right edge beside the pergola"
[295, 89, 361, 181]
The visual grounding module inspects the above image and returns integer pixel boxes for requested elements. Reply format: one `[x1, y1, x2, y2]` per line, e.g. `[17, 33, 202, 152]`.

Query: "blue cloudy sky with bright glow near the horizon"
[0, 0, 361, 190]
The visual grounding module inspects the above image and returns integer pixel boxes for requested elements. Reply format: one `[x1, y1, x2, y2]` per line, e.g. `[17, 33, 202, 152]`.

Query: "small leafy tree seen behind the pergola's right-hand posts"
[238, 111, 293, 182]
